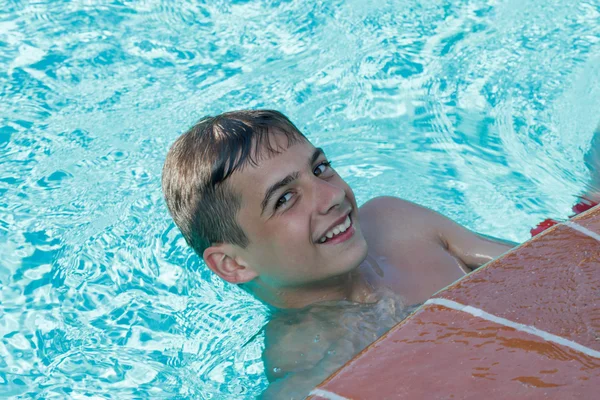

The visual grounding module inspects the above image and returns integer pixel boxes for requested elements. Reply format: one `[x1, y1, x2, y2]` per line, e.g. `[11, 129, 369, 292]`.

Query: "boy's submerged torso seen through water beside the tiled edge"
[263, 288, 418, 399]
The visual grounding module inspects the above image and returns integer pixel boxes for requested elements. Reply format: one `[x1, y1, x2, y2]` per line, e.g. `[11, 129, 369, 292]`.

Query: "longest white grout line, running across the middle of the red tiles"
[425, 299, 600, 358]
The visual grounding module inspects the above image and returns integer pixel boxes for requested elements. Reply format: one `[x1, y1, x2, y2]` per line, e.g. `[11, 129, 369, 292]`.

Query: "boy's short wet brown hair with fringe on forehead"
[162, 110, 306, 257]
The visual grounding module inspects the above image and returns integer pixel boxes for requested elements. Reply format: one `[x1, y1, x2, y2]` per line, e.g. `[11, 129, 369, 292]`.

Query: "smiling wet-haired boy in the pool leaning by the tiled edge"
[162, 110, 596, 398]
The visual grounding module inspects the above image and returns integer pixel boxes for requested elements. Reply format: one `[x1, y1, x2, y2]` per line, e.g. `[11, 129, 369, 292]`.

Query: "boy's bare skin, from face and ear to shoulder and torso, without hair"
[203, 135, 515, 398]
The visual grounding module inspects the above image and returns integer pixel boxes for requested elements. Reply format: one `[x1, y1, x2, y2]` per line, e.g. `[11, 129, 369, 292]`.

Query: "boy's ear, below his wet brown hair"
[202, 244, 258, 284]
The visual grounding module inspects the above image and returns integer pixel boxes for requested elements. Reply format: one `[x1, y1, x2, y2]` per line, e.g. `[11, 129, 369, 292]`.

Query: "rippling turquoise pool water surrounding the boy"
[0, 0, 600, 399]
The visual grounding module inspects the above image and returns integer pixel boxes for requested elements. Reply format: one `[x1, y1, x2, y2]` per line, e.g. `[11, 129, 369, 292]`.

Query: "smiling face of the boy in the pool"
[229, 135, 367, 288]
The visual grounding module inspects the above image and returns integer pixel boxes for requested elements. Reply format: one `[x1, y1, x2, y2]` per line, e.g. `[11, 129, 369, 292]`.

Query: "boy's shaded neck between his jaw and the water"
[248, 268, 374, 308]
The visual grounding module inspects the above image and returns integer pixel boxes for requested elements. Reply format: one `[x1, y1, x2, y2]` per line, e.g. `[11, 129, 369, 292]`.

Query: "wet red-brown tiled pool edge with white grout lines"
[311, 206, 600, 400]
